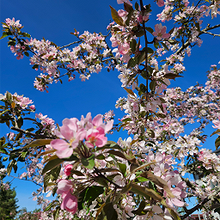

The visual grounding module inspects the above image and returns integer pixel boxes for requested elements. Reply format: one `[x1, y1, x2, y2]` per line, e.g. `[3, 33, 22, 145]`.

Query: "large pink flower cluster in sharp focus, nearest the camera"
[50, 113, 113, 158]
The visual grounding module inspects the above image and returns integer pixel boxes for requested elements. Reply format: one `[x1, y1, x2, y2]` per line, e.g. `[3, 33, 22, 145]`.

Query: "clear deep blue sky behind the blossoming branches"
[0, 0, 220, 210]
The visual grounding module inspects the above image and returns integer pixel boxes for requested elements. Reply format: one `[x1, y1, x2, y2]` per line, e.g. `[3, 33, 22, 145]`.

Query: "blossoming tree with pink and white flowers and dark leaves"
[0, 0, 220, 220]
